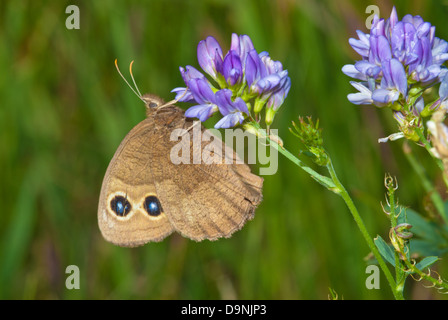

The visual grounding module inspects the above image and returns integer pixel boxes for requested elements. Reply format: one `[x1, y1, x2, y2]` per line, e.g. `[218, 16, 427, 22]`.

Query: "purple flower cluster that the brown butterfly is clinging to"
[172, 33, 291, 128]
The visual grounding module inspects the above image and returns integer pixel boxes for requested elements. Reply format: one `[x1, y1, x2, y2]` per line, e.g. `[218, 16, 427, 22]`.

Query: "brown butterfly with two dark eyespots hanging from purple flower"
[98, 64, 263, 247]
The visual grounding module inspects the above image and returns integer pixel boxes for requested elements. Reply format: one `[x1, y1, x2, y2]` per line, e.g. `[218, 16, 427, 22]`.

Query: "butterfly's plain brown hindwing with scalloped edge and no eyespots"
[150, 107, 263, 241]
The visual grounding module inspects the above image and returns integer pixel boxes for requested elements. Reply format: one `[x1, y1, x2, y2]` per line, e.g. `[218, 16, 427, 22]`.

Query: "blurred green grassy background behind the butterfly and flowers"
[0, 0, 448, 299]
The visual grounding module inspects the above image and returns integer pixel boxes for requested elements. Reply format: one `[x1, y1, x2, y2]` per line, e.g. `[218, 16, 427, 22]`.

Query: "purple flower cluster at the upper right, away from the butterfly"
[342, 7, 448, 115]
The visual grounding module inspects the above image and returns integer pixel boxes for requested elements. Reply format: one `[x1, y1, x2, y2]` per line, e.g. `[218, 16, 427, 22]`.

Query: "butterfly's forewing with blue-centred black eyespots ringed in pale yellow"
[98, 119, 174, 247]
